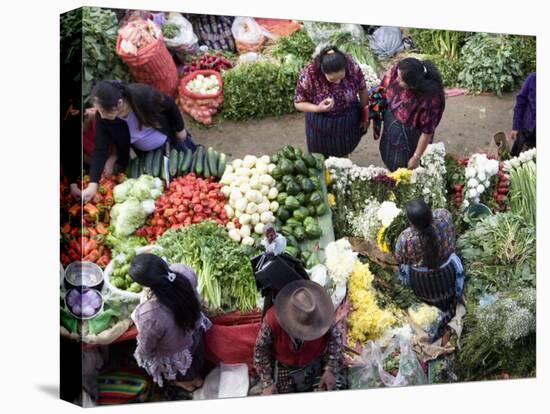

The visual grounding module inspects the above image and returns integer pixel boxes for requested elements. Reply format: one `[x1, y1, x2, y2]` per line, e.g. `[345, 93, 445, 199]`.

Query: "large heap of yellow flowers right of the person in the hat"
[348, 260, 397, 346]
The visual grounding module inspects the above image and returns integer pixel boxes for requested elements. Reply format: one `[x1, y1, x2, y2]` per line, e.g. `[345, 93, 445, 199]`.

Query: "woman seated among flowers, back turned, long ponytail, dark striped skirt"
[394, 199, 464, 345]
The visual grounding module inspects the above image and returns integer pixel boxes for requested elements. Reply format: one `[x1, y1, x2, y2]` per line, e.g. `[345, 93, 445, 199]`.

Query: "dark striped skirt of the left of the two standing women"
[306, 103, 362, 157]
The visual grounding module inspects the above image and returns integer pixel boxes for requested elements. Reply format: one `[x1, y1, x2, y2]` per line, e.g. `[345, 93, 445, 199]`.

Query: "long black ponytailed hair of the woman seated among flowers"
[405, 198, 441, 269]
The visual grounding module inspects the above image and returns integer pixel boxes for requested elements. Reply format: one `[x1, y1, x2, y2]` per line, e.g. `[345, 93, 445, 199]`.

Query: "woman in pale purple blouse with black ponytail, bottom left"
[129, 253, 212, 392]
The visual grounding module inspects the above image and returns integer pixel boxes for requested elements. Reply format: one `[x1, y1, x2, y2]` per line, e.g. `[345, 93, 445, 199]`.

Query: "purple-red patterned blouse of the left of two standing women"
[294, 55, 366, 116]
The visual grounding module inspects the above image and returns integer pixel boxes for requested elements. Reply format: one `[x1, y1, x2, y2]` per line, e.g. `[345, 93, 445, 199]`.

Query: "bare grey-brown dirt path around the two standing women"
[187, 93, 516, 166]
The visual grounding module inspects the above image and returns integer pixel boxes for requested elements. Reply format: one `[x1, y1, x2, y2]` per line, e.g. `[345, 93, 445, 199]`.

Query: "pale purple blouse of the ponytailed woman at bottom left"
[132, 264, 212, 387]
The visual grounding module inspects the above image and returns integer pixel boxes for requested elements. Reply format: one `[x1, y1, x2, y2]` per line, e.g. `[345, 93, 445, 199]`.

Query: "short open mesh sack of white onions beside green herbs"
[178, 70, 223, 125]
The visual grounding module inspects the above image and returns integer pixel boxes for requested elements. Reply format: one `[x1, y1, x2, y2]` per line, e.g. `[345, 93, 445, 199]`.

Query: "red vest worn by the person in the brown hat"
[265, 308, 328, 367]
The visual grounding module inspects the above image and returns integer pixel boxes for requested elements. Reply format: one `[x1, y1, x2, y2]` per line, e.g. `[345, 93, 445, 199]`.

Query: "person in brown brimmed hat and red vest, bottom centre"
[254, 280, 341, 395]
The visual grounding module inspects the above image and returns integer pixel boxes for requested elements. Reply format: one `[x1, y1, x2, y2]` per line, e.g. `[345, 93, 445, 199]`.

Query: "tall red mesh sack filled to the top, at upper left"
[116, 19, 178, 97]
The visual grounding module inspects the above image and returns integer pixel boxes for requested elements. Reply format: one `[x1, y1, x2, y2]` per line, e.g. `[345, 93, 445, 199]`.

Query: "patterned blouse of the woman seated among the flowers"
[394, 208, 456, 267]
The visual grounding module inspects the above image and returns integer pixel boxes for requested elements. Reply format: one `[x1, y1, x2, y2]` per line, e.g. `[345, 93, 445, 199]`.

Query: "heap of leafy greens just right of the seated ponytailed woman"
[457, 212, 536, 302]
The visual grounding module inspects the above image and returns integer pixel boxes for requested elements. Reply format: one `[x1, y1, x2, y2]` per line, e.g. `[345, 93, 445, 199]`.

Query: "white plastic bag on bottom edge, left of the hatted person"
[193, 363, 249, 400]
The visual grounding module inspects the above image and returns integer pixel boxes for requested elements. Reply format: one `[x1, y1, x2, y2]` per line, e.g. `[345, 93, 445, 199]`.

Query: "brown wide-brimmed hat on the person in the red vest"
[275, 280, 335, 341]
